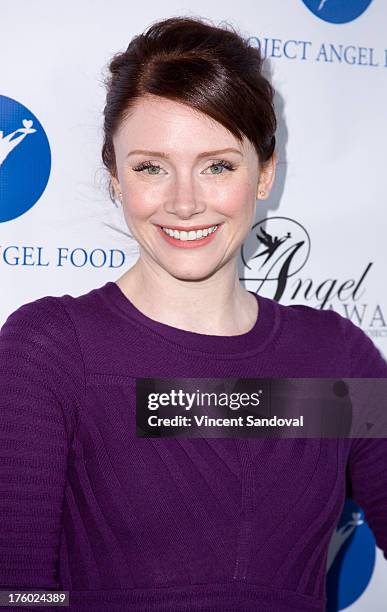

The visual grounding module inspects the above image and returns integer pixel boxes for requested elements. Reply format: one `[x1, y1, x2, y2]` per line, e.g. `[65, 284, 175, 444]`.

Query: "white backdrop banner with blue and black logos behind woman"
[0, 0, 387, 612]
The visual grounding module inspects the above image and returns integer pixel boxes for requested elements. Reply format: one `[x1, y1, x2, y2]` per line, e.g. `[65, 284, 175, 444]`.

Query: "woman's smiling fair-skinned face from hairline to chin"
[113, 96, 275, 280]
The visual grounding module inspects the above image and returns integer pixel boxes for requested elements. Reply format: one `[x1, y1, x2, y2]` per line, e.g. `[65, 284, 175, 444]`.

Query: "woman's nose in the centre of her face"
[165, 170, 206, 219]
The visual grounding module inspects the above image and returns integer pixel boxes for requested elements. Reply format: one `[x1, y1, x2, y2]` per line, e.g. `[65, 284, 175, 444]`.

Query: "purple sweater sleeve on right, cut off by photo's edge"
[344, 320, 387, 560]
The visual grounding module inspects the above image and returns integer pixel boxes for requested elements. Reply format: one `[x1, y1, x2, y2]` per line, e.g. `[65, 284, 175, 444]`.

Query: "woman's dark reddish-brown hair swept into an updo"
[102, 17, 277, 201]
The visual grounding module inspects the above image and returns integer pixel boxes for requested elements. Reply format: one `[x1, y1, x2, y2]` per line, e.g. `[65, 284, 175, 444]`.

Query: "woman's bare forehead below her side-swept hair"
[113, 95, 252, 152]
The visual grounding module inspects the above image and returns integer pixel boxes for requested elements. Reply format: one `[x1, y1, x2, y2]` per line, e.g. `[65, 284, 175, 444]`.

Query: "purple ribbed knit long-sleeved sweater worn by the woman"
[0, 282, 387, 612]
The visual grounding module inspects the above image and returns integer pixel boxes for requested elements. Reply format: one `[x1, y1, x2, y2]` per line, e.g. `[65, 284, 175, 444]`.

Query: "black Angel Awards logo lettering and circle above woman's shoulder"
[244, 217, 387, 338]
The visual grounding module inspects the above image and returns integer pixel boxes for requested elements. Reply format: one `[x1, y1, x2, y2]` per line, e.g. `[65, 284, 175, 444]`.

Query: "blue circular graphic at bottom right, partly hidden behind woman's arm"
[326, 498, 376, 612]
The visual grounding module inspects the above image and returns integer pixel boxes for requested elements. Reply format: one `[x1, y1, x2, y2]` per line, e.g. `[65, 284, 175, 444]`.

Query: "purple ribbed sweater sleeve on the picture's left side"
[0, 296, 84, 590]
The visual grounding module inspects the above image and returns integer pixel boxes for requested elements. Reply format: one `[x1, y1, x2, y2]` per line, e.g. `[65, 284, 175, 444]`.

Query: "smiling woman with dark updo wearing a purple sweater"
[0, 18, 387, 612]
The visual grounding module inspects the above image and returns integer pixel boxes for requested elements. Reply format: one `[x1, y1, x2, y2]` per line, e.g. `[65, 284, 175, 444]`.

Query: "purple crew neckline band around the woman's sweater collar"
[102, 281, 281, 355]
